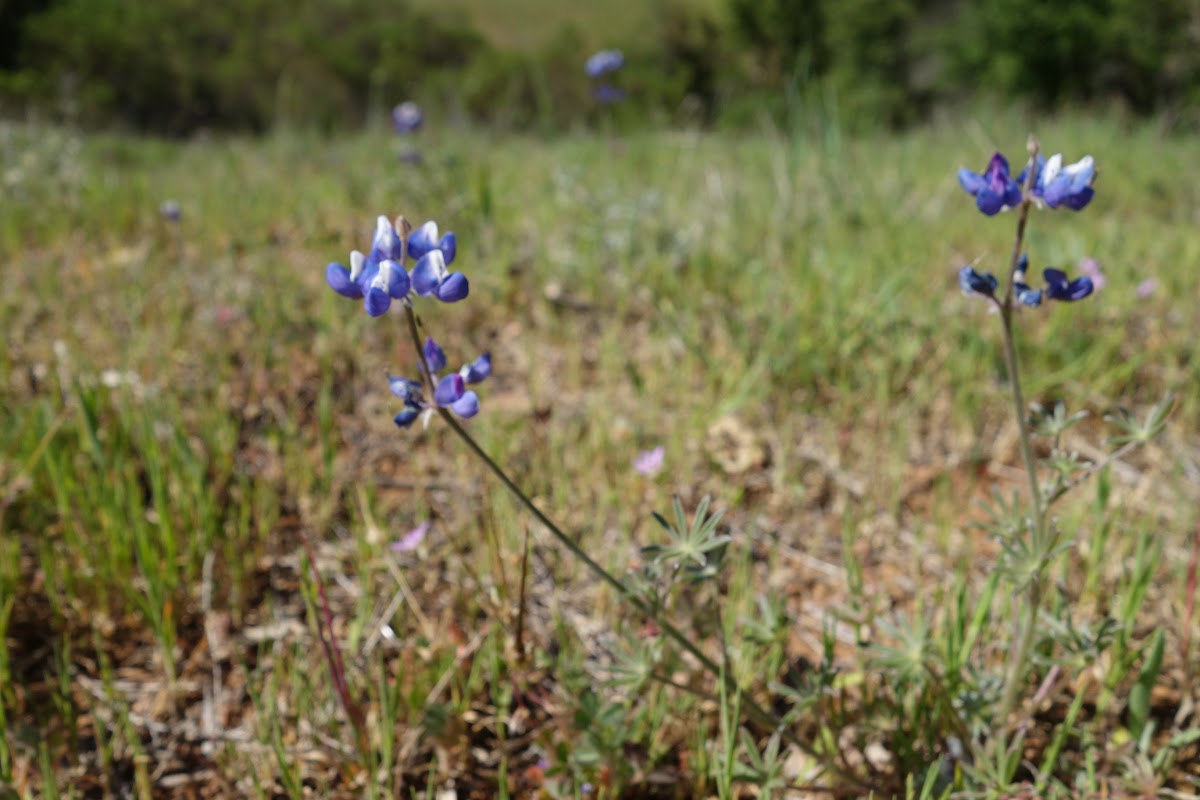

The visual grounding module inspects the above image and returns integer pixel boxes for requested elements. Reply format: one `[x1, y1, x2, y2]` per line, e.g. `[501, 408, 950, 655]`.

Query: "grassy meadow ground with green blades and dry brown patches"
[0, 110, 1200, 800]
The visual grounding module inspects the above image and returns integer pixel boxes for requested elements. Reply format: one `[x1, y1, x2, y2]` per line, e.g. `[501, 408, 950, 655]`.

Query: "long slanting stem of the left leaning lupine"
[404, 305, 864, 787]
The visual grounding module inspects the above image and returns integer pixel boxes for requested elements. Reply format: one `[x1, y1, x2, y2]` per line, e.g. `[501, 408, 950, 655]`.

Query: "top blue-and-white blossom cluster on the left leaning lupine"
[325, 216, 470, 317]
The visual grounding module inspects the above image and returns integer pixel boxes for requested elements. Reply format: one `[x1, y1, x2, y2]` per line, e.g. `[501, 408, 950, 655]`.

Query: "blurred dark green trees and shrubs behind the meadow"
[0, 0, 1200, 136]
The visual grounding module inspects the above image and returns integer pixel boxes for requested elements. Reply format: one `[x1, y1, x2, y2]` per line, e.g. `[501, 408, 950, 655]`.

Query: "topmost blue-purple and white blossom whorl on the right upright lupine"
[959, 152, 1096, 217]
